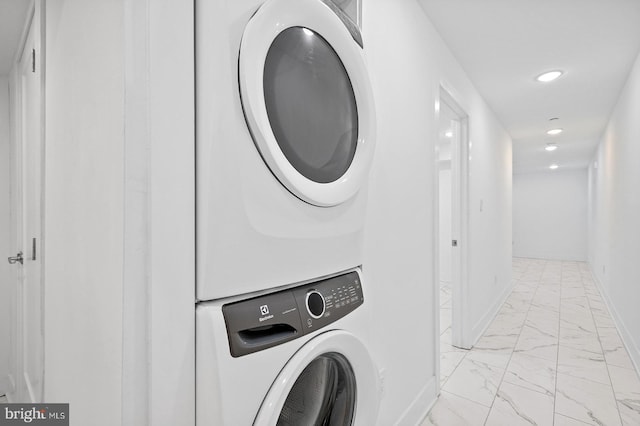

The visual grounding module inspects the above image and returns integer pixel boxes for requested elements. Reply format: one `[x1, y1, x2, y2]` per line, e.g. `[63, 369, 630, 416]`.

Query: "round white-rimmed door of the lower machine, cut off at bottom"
[254, 330, 379, 426]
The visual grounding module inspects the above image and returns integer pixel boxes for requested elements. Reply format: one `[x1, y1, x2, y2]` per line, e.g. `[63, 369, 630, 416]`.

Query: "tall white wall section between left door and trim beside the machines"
[43, 0, 124, 425]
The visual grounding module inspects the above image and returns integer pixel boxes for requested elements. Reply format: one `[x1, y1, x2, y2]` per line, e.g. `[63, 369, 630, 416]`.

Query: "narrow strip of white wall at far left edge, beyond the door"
[0, 76, 10, 395]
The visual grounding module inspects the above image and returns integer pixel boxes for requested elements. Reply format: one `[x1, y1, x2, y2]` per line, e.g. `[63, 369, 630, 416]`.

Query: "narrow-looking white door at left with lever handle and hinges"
[8, 11, 44, 402]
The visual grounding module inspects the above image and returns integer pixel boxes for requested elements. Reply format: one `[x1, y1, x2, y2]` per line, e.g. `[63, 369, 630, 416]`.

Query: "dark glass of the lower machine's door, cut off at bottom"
[277, 353, 356, 426]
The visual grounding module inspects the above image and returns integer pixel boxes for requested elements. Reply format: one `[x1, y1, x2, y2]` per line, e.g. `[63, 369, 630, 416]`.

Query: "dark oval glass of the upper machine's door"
[263, 27, 358, 183]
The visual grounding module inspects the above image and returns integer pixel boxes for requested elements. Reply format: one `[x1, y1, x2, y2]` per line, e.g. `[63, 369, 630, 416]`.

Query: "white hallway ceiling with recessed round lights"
[419, 0, 640, 173]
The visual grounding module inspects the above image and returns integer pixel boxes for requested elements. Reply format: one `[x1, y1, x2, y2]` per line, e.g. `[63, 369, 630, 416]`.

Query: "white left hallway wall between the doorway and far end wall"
[462, 95, 512, 342]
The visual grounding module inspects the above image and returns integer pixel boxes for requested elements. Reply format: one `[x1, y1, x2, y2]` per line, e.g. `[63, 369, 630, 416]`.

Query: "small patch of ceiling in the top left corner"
[0, 0, 31, 75]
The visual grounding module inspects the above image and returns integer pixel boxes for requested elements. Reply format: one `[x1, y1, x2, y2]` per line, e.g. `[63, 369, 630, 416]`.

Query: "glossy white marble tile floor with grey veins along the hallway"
[421, 258, 640, 426]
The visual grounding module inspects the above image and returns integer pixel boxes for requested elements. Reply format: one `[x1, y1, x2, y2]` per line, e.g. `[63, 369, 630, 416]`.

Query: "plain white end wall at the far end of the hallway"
[513, 169, 587, 261]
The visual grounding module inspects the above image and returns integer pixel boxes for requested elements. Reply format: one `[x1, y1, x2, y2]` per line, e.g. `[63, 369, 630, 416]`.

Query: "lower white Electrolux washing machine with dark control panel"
[196, 269, 380, 426]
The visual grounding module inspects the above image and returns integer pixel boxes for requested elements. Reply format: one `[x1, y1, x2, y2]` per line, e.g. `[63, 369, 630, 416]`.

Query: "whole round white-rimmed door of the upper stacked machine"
[239, 0, 375, 207]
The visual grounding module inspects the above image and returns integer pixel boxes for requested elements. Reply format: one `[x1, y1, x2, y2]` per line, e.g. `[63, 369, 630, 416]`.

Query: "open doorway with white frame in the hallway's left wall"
[435, 88, 471, 385]
